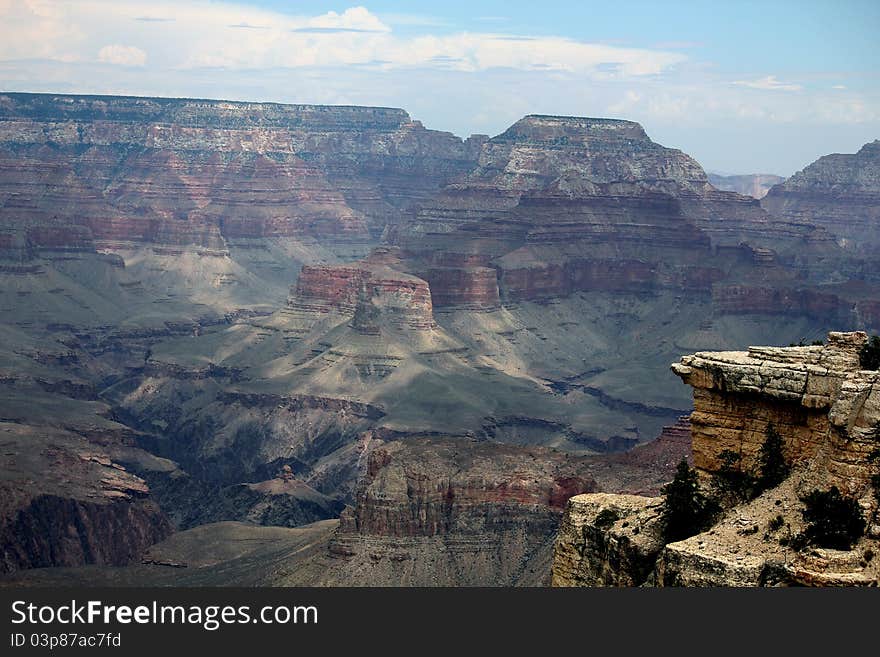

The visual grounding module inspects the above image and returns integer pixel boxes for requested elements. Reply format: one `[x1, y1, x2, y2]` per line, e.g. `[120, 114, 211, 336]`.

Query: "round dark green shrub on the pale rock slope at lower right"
[801, 486, 865, 550]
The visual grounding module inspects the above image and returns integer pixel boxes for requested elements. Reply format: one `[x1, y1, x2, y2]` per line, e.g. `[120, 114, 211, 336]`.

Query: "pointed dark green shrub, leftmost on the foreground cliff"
[662, 459, 718, 543]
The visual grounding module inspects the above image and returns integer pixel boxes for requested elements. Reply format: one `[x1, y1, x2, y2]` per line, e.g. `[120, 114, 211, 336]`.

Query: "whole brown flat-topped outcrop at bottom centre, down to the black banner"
[329, 437, 595, 586]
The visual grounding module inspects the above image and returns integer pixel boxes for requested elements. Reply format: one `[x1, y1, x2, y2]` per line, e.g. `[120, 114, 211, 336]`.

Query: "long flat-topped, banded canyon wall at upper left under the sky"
[0, 89, 482, 249]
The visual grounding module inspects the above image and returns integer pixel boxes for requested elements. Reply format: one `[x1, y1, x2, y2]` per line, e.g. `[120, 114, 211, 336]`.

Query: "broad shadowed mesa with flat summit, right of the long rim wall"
[389, 116, 835, 309]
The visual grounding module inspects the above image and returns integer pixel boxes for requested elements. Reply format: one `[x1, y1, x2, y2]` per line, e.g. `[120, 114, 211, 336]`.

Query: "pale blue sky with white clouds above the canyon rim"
[0, 0, 880, 176]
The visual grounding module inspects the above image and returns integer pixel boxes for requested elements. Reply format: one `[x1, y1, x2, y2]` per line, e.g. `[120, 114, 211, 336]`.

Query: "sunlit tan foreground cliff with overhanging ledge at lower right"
[553, 333, 880, 586]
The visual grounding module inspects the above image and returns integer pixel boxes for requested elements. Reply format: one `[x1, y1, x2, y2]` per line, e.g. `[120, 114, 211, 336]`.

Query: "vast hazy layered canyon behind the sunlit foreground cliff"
[0, 93, 880, 585]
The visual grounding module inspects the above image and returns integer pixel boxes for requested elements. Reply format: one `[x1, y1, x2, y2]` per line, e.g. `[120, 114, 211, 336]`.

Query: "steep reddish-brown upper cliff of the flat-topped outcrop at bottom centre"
[340, 438, 595, 537]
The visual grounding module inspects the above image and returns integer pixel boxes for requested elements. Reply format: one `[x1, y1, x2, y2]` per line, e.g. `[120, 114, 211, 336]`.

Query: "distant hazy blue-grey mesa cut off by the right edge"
[761, 140, 880, 250]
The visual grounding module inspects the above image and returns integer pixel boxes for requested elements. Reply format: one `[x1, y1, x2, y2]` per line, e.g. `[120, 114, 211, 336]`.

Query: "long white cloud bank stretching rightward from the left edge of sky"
[0, 0, 687, 79]
